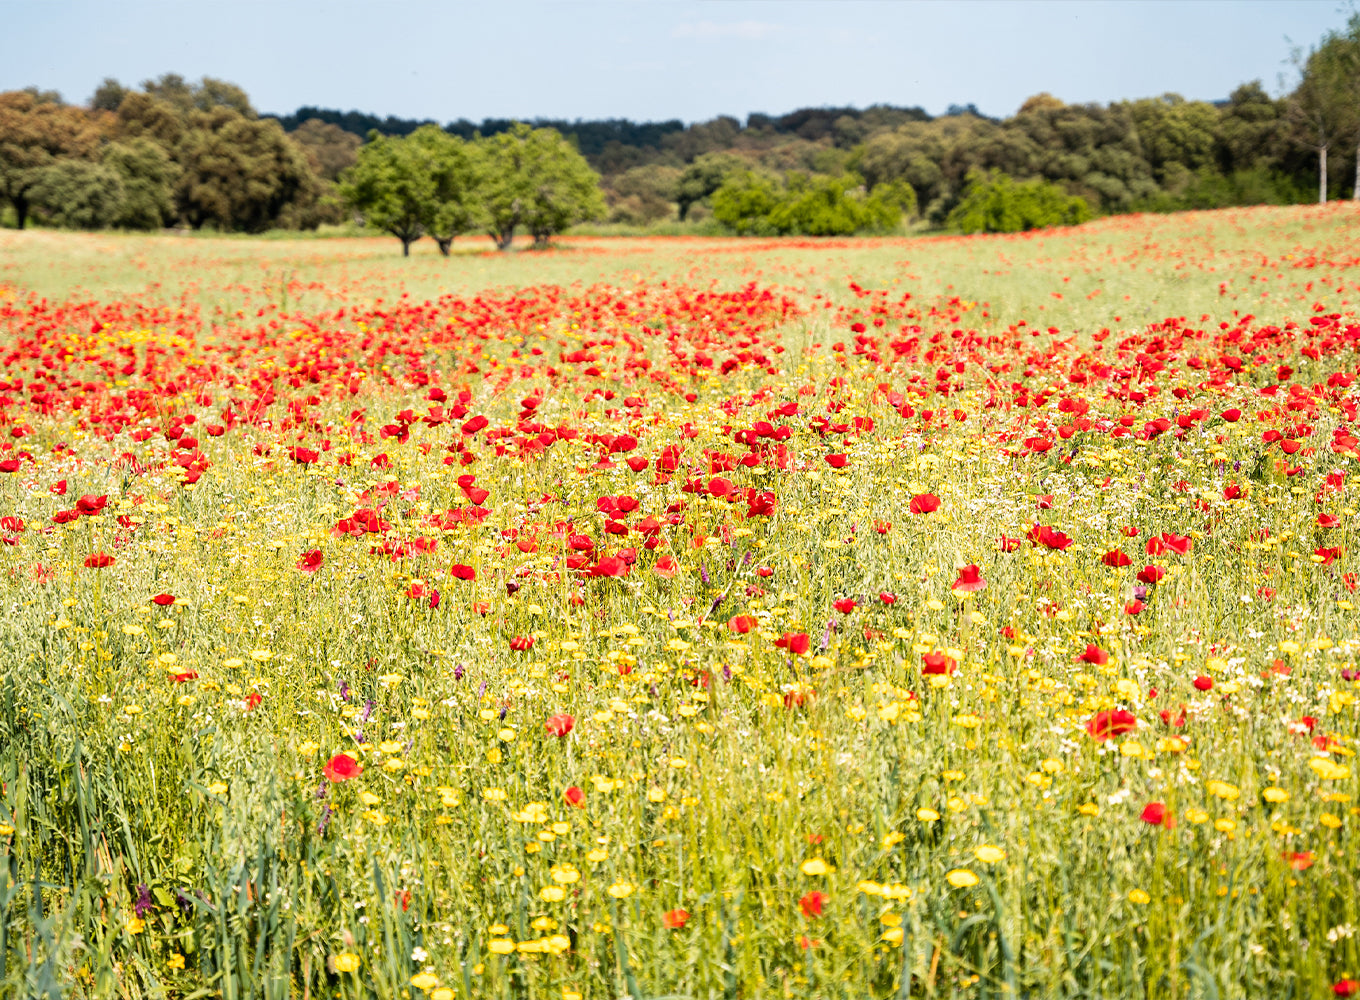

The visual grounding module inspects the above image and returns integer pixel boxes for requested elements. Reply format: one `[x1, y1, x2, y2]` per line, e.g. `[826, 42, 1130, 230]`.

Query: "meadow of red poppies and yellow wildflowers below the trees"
[0, 204, 1360, 1000]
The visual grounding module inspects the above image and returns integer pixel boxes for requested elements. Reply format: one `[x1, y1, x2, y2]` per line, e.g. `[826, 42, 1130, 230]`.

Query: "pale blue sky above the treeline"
[0, 0, 1352, 122]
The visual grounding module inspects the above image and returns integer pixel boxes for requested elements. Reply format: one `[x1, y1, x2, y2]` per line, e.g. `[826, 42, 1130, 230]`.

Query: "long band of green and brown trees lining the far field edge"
[0, 15, 1360, 242]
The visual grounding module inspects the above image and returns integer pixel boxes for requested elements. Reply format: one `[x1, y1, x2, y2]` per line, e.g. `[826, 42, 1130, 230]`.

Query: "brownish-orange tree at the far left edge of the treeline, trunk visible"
[0, 90, 101, 229]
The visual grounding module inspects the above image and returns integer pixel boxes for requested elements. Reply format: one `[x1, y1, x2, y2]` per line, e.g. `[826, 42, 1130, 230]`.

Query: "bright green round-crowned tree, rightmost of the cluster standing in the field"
[473, 122, 605, 250]
